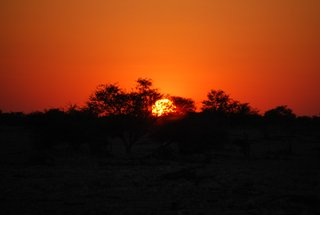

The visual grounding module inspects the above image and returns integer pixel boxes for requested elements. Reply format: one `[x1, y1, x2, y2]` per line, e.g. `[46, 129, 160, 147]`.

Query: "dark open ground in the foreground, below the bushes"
[0, 126, 320, 215]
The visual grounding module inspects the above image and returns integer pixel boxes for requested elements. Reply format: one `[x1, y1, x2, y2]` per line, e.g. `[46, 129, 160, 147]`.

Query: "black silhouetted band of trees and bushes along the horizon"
[0, 78, 319, 163]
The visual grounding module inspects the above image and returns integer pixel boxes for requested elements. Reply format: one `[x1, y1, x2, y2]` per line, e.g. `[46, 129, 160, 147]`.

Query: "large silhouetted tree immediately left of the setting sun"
[87, 78, 161, 154]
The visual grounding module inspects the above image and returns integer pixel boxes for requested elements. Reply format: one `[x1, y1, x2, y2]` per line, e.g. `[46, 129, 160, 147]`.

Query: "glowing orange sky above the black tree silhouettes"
[0, 0, 320, 115]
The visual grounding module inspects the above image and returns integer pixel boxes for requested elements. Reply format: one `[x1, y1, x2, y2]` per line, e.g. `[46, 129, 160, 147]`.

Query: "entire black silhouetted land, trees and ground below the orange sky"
[0, 78, 320, 215]
